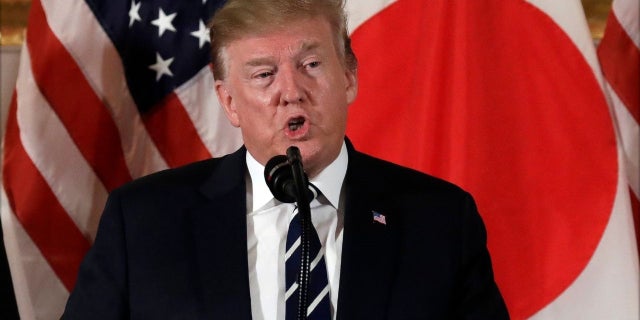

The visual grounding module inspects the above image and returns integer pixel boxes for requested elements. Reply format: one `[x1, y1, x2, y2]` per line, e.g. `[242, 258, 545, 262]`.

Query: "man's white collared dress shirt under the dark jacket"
[246, 142, 348, 320]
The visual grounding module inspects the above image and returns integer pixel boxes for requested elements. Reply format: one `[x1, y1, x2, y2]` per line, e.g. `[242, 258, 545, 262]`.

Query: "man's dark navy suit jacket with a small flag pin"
[63, 144, 508, 320]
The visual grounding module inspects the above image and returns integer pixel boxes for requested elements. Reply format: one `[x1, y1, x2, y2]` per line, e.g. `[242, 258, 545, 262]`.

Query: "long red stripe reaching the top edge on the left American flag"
[27, 0, 131, 190]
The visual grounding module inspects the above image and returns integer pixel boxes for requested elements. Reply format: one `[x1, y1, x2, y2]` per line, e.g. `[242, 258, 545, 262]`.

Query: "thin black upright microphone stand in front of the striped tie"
[287, 146, 313, 320]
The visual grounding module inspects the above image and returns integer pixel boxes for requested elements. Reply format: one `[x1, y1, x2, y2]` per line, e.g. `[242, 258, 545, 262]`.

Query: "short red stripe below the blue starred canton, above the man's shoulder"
[142, 92, 211, 168]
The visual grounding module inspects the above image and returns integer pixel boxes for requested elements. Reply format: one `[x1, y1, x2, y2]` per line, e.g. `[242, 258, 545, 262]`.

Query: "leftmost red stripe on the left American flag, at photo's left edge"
[3, 94, 90, 290]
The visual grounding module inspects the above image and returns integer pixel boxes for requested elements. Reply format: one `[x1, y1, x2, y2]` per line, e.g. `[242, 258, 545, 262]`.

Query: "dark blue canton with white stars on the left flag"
[86, 0, 224, 113]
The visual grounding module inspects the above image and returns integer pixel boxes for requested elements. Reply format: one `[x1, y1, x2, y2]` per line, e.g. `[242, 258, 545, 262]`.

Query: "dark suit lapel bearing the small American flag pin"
[338, 143, 397, 319]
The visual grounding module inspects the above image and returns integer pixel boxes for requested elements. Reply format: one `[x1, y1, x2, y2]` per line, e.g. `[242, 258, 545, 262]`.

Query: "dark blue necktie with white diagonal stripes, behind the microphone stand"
[285, 190, 331, 320]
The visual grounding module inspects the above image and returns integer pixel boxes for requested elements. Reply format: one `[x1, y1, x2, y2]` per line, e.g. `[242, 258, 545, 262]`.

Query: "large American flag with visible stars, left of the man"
[2, 0, 241, 319]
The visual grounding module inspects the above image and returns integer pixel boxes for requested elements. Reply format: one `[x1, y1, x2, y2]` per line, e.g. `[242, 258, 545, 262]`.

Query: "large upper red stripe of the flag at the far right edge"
[598, 12, 640, 123]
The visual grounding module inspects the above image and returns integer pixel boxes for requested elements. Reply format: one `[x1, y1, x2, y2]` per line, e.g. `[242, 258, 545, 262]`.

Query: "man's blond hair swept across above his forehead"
[209, 0, 358, 80]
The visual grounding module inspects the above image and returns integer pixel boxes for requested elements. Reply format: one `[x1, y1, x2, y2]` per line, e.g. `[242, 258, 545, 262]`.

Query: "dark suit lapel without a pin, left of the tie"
[192, 148, 251, 319]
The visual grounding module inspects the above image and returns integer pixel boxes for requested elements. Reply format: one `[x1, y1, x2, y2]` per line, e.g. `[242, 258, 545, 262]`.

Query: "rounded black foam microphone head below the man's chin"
[264, 155, 296, 203]
